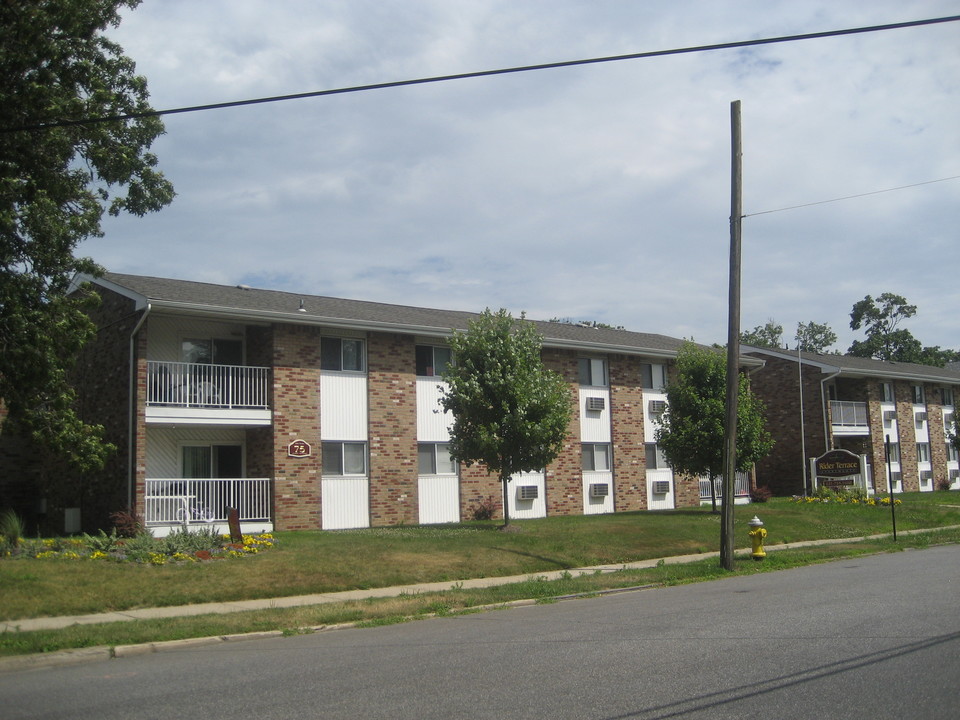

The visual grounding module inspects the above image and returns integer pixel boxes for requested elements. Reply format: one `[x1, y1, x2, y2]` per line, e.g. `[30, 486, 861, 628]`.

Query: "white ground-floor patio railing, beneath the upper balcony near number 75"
[144, 478, 270, 525]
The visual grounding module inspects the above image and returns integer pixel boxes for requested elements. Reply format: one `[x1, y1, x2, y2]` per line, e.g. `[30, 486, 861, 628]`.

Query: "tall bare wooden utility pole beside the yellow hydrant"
[720, 100, 743, 570]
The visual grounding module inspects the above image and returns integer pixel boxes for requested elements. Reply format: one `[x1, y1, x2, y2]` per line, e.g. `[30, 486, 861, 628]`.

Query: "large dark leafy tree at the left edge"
[0, 0, 174, 469]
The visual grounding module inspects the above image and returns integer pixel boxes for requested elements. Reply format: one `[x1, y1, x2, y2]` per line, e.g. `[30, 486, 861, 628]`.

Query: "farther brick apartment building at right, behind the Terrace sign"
[742, 347, 960, 495]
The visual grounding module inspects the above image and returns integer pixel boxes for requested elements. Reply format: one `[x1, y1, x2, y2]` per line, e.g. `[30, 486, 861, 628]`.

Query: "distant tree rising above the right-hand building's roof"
[847, 292, 958, 367]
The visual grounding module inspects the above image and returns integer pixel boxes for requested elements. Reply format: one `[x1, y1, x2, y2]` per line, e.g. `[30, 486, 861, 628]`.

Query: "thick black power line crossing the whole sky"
[0, 15, 960, 133]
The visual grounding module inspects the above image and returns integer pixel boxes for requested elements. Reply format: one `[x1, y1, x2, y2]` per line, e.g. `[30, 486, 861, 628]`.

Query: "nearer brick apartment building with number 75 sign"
[0, 274, 761, 534]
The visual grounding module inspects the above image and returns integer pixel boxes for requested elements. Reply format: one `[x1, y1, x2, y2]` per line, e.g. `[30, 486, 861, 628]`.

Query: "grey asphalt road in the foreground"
[0, 546, 960, 720]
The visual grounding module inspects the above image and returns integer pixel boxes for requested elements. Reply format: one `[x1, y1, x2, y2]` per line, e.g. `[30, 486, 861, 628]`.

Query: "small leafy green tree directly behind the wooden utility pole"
[654, 342, 773, 512]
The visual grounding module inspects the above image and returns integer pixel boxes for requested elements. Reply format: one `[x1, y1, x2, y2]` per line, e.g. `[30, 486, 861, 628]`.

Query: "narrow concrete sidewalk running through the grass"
[0, 526, 928, 632]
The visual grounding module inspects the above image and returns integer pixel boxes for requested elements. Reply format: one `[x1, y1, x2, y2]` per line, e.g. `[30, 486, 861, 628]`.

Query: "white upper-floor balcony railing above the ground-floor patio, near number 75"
[147, 360, 270, 410]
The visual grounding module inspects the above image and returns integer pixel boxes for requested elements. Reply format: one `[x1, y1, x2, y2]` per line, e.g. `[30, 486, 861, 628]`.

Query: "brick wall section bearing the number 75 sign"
[270, 325, 322, 530]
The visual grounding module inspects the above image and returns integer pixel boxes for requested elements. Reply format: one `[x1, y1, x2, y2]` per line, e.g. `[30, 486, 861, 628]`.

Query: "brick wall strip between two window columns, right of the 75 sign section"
[367, 333, 419, 526]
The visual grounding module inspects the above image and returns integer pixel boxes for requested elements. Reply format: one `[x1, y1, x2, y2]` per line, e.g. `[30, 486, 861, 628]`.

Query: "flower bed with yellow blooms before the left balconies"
[0, 529, 275, 565]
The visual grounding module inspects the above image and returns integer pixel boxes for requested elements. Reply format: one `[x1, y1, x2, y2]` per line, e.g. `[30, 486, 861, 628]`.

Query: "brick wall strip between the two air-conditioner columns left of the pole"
[610, 355, 647, 512]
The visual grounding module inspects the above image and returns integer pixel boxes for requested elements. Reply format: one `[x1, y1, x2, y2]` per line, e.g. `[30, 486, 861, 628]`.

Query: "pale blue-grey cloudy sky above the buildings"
[80, 0, 960, 349]
